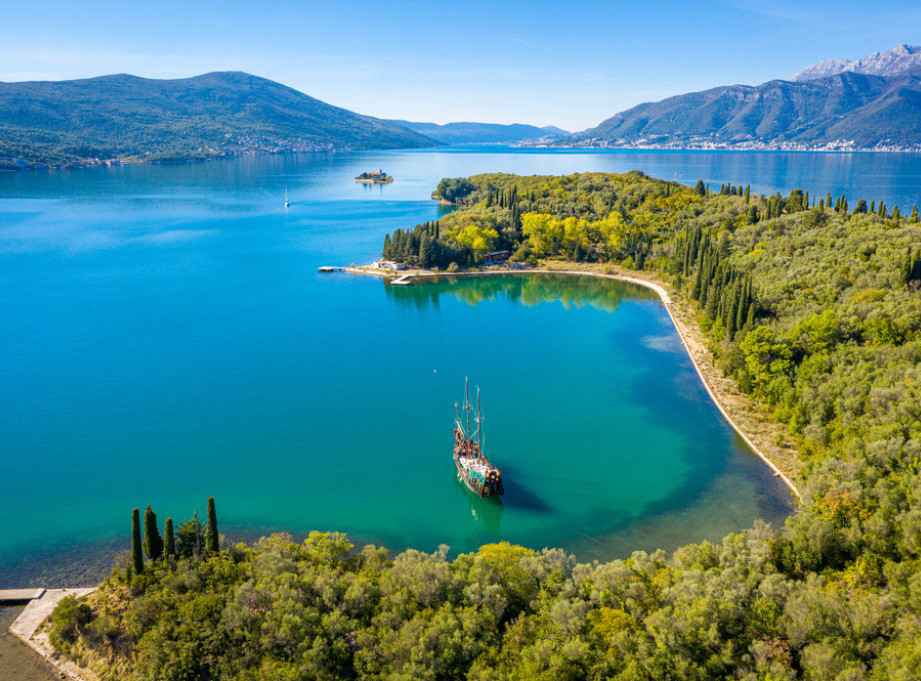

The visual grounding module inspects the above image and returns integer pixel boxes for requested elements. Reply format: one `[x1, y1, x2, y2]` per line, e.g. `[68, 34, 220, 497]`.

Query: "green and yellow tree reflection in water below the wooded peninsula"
[386, 272, 656, 312]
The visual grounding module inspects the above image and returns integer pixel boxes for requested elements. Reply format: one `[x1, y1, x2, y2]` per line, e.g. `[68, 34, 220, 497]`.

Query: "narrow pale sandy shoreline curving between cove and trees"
[345, 262, 803, 503]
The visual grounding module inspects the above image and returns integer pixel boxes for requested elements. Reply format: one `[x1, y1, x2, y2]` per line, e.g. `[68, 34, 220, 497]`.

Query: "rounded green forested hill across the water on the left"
[0, 72, 437, 168]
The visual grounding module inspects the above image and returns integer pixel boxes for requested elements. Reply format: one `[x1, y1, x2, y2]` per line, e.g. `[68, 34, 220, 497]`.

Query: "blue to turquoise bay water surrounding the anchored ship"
[0, 149, 918, 584]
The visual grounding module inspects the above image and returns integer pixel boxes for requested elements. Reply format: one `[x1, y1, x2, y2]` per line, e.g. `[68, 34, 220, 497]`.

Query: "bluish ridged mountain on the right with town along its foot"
[572, 70, 921, 149]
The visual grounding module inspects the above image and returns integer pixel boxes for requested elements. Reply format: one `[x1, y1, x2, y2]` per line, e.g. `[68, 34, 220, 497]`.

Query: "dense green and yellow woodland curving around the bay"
[52, 172, 921, 681]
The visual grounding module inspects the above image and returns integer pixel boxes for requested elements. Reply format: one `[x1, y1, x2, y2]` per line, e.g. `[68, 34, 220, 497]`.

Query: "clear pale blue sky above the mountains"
[0, 0, 921, 131]
